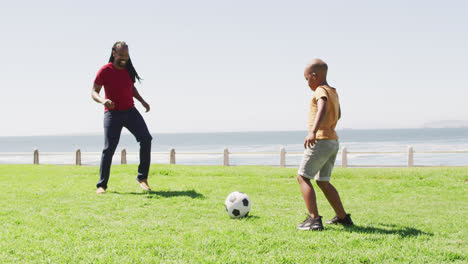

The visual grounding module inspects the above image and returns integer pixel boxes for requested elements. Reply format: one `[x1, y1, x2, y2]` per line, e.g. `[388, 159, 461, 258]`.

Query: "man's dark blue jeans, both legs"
[96, 108, 153, 189]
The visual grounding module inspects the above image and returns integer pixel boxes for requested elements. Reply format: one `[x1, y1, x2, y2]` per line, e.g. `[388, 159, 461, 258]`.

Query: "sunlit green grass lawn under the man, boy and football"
[0, 165, 468, 263]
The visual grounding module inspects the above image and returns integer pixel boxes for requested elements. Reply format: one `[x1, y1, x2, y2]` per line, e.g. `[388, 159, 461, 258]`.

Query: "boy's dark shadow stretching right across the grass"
[344, 224, 434, 238]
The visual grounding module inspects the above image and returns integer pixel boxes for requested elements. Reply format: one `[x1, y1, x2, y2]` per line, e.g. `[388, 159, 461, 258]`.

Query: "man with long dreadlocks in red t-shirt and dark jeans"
[92, 41, 152, 194]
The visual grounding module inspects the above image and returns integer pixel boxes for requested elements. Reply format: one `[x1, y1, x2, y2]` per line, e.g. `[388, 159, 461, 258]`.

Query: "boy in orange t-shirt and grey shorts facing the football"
[297, 59, 353, 231]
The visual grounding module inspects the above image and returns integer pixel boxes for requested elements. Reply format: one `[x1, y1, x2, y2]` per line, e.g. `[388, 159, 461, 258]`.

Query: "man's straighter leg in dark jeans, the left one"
[96, 111, 122, 190]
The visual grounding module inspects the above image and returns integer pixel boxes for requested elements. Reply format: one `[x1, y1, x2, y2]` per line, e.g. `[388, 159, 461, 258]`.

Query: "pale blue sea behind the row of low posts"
[0, 127, 468, 167]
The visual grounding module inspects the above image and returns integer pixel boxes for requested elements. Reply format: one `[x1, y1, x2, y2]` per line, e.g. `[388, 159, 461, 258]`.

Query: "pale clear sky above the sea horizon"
[0, 0, 468, 136]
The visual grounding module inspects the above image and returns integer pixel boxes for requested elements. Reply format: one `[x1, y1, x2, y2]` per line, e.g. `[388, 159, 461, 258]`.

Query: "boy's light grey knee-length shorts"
[297, 139, 339, 181]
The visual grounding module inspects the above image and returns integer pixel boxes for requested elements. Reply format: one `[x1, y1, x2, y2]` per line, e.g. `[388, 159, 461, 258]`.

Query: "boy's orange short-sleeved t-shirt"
[309, 85, 340, 139]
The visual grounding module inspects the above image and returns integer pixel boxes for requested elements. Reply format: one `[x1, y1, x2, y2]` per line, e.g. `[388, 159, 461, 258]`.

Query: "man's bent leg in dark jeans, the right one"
[125, 108, 153, 184]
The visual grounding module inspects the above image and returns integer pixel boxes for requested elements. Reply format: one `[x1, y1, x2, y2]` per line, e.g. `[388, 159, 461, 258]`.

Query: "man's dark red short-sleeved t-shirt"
[94, 62, 135, 111]
